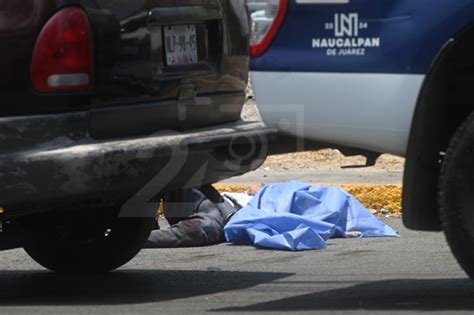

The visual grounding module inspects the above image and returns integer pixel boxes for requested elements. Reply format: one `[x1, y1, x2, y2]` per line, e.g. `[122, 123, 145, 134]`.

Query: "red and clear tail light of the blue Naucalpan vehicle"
[246, 0, 288, 58]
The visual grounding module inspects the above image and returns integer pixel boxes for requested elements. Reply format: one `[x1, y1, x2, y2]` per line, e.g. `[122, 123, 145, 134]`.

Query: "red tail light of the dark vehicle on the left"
[31, 7, 94, 93]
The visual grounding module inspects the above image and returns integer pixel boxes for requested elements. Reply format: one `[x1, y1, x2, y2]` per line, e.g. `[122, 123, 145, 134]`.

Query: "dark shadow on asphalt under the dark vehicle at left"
[0, 270, 292, 306]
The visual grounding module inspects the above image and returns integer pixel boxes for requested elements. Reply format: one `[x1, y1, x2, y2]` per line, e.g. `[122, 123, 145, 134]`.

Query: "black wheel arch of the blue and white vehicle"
[403, 25, 474, 231]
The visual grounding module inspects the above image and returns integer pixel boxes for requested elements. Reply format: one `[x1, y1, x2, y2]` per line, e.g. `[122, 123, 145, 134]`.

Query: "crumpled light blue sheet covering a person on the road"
[224, 181, 398, 251]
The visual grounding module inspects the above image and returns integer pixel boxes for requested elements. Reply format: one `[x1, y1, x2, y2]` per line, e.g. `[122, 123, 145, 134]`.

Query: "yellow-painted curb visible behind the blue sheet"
[214, 183, 402, 214]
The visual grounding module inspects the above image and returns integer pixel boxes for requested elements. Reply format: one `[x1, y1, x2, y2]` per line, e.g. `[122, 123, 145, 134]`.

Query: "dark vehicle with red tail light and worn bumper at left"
[0, 0, 273, 272]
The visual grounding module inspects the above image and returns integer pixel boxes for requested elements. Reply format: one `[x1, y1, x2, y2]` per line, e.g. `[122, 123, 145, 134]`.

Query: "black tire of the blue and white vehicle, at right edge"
[439, 113, 474, 279]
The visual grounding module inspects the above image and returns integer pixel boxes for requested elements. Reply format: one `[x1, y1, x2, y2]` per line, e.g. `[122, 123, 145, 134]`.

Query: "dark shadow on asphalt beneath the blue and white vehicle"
[213, 279, 474, 312]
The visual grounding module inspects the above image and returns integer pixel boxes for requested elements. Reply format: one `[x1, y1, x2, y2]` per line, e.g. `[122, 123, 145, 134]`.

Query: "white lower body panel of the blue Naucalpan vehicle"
[251, 71, 425, 156]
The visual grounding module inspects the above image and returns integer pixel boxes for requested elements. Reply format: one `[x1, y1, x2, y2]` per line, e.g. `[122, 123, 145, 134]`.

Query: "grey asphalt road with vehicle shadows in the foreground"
[0, 219, 474, 314]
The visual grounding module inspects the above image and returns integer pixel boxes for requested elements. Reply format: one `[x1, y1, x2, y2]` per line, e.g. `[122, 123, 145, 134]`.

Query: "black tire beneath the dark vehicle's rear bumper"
[24, 210, 155, 273]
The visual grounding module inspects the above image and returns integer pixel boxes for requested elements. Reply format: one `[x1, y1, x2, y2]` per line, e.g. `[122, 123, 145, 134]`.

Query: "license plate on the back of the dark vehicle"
[164, 25, 198, 66]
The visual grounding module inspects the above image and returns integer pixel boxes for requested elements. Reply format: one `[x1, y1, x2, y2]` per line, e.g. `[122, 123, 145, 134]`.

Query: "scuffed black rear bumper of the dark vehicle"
[0, 113, 275, 217]
